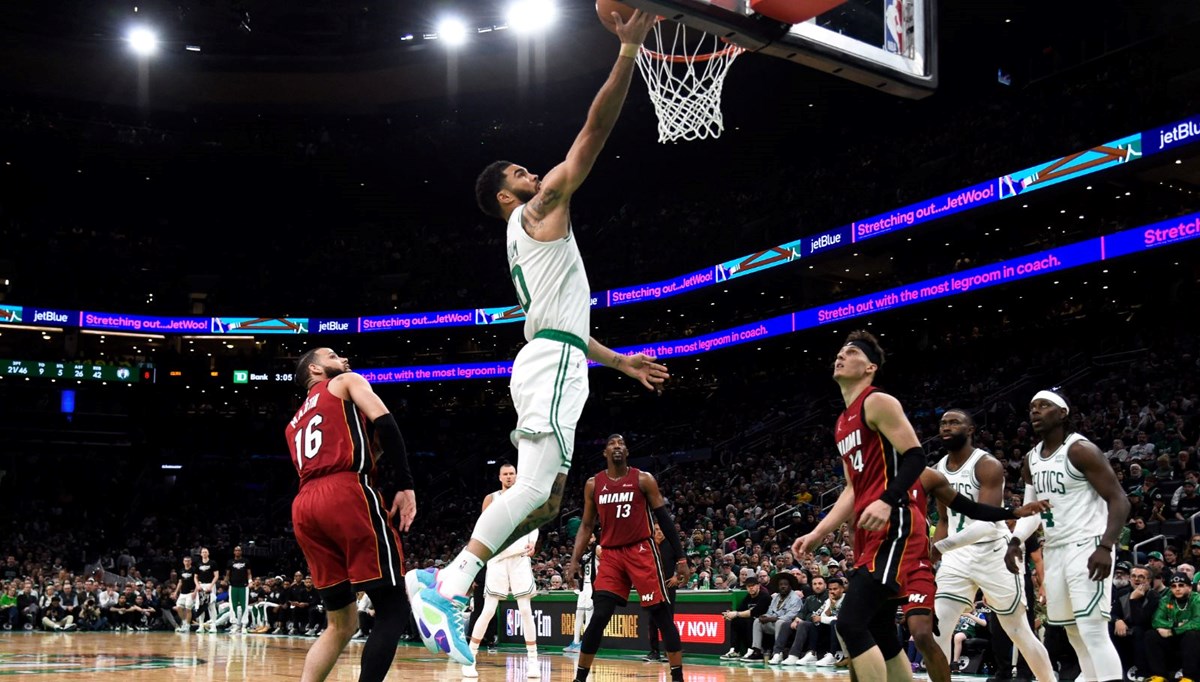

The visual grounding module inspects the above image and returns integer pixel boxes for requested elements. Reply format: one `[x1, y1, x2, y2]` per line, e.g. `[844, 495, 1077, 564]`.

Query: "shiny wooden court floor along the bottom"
[0, 632, 864, 682]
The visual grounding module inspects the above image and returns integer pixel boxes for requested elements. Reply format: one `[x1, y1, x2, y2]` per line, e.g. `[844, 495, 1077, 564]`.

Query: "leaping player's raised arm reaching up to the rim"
[522, 10, 656, 241]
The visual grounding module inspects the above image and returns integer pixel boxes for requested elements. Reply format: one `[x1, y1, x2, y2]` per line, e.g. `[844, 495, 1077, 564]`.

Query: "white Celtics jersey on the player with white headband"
[1026, 433, 1109, 548]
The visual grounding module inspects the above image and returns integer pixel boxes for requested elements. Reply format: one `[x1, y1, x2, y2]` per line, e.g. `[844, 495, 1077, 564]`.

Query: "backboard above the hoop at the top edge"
[625, 0, 937, 98]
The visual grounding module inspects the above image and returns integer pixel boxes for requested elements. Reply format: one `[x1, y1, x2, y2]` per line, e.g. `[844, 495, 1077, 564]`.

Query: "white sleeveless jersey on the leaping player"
[506, 204, 592, 343]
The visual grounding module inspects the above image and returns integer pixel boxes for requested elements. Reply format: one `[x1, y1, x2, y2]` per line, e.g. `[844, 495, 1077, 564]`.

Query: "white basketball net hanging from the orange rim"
[637, 22, 745, 143]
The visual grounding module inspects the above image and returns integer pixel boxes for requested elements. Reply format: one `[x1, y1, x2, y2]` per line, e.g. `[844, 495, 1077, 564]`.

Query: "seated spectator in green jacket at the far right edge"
[1146, 575, 1200, 682]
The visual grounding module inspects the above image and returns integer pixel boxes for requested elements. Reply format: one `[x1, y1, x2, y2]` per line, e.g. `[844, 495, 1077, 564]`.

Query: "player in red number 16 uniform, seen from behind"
[287, 348, 416, 682]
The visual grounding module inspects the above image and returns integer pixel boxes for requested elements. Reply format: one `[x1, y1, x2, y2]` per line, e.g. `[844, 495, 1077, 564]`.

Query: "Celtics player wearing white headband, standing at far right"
[1006, 390, 1129, 682]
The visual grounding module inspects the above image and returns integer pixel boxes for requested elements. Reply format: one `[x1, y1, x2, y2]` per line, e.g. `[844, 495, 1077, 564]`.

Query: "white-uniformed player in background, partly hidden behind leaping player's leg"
[462, 462, 541, 680]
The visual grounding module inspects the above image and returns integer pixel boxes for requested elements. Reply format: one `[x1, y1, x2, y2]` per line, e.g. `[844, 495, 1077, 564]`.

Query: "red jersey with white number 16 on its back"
[284, 381, 374, 487]
